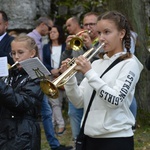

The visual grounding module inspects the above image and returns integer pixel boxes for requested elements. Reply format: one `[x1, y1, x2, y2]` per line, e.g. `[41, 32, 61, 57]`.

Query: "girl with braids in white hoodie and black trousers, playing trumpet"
[61, 11, 143, 150]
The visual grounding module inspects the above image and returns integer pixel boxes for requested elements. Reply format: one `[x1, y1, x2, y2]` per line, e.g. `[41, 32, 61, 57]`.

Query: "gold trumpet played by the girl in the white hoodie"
[40, 43, 105, 99]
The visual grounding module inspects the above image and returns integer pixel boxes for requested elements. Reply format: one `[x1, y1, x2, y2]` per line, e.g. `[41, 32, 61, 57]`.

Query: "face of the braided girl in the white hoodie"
[97, 19, 125, 56]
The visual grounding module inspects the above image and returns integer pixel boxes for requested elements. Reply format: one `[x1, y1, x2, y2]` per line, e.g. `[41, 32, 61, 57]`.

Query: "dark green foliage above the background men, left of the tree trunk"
[51, 0, 104, 25]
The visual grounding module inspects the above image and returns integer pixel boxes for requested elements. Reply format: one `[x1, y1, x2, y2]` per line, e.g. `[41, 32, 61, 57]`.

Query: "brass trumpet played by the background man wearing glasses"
[69, 30, 91, 51]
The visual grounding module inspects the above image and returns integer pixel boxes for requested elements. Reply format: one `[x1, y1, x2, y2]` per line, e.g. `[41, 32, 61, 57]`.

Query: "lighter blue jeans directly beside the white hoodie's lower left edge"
[68, 101, 83, 139]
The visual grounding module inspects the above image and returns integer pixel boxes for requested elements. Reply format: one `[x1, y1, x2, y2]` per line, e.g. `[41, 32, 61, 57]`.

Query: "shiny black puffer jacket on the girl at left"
[0, 69, 43, 150]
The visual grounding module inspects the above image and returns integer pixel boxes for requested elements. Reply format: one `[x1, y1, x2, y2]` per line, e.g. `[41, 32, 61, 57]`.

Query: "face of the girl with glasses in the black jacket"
[11, 41, 36, 67]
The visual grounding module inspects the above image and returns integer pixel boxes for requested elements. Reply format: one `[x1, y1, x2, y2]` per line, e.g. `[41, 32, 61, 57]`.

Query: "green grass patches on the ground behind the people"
[41, 102, 150, 150]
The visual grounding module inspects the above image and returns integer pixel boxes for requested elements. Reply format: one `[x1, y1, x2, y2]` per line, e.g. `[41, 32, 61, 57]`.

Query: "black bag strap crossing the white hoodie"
[81, 57, 123, 132]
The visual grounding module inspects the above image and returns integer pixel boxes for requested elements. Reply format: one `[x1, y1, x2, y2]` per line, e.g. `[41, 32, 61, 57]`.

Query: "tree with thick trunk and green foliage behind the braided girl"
[51, 0, 150, 115]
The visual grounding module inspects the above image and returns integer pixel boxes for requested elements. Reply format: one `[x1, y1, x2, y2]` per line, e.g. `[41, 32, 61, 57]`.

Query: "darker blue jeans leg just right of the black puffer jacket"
[41, 95, 60, 148]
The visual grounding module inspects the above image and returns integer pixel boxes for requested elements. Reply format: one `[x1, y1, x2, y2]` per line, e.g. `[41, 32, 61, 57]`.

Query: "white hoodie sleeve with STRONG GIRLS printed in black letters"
[85, 59, 143, 108]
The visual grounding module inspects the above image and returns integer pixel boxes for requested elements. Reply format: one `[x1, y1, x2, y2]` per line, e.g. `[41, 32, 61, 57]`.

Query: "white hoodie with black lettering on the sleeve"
[65, 52, 143, 138]
